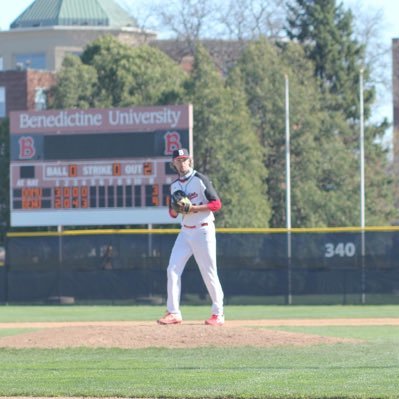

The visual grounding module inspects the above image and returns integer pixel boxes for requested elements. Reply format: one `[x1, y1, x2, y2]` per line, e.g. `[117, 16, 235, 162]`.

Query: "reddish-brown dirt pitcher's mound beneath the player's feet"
[0, 322, 357, 348]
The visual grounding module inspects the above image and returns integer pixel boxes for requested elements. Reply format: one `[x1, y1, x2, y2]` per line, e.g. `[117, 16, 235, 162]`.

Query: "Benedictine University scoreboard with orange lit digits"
[10, 104, 193, 226]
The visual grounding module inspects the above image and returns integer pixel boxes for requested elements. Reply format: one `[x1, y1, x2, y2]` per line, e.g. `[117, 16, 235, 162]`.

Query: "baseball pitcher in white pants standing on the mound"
[158, 148, 224, 326]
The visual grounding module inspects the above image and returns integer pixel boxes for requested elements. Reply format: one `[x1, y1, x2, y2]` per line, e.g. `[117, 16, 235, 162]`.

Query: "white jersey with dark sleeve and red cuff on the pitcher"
[170, 170, 222, 226]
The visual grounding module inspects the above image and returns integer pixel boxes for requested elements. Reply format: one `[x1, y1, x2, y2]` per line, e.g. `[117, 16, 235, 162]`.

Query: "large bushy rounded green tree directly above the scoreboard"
[82, 36, 185, 106]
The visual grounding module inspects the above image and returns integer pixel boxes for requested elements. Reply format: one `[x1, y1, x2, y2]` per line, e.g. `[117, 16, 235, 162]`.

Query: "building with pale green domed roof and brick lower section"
[0, 0, 156, 118]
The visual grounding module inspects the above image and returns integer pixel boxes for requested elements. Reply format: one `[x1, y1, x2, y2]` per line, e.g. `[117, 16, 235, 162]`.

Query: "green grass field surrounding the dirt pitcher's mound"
[0, 306, 399, 399]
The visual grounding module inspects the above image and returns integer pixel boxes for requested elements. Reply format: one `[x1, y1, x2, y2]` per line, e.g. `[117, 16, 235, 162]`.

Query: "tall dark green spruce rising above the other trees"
[287, 0, 374, 121]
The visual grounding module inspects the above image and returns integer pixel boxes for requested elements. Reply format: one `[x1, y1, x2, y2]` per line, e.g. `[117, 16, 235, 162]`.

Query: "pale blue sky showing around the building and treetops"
[0, 0, 399, 144]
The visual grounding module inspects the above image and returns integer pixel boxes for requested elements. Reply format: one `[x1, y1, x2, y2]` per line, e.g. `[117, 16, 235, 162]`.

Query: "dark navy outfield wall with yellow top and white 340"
[0, 227, 399, 304]
